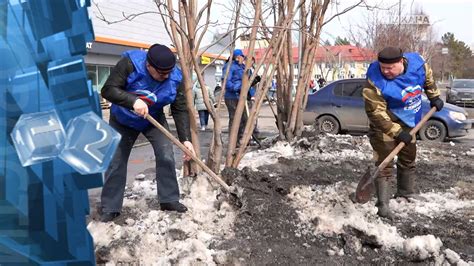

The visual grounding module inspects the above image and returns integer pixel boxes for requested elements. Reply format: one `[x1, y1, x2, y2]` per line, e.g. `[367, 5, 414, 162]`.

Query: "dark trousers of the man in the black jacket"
[101, 113, 179, 212]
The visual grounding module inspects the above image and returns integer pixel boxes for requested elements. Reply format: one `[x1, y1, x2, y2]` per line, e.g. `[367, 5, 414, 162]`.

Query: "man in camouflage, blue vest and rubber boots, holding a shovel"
[363, 47, 444, 219]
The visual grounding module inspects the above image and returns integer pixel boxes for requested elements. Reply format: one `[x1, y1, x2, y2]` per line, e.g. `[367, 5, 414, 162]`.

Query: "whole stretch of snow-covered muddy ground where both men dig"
[88, 133, 474, 265]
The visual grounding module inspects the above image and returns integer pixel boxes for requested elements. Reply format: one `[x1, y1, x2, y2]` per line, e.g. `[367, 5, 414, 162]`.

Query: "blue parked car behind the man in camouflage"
[303, 79, 472, 141]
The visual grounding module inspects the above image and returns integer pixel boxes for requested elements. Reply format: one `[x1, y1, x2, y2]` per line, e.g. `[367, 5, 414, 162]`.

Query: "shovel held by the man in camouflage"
[353, 107, 436, 204]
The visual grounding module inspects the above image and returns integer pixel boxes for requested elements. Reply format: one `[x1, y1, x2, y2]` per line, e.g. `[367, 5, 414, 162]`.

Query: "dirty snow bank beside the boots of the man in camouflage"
[289, 182, 404, 250]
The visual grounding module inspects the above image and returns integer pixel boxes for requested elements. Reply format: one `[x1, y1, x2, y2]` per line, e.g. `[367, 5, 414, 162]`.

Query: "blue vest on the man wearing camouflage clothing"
[367, 53, 426, 127]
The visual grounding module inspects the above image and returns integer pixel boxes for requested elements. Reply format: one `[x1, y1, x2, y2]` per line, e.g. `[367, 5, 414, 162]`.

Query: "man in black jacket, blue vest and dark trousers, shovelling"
[100, 44, 194, 222]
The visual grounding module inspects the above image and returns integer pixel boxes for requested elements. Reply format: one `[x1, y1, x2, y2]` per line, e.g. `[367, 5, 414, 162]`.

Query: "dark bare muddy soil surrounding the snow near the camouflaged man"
[216, 137, 474, 265]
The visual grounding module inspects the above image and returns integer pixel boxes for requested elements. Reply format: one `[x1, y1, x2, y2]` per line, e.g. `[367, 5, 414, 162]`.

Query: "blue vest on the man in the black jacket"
[111, 50, 182, 131]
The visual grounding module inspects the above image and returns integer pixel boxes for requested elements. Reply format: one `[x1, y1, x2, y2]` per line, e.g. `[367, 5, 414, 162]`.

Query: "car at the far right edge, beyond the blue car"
[446, 79, 474, 107]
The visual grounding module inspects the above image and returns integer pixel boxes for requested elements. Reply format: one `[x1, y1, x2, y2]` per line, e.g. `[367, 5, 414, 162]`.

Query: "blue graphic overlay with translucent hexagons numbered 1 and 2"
[0, 0, 117, 265]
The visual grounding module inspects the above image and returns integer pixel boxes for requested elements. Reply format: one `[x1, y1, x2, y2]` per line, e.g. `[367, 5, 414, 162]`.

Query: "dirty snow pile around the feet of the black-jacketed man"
[88, 171, 235, 265]
